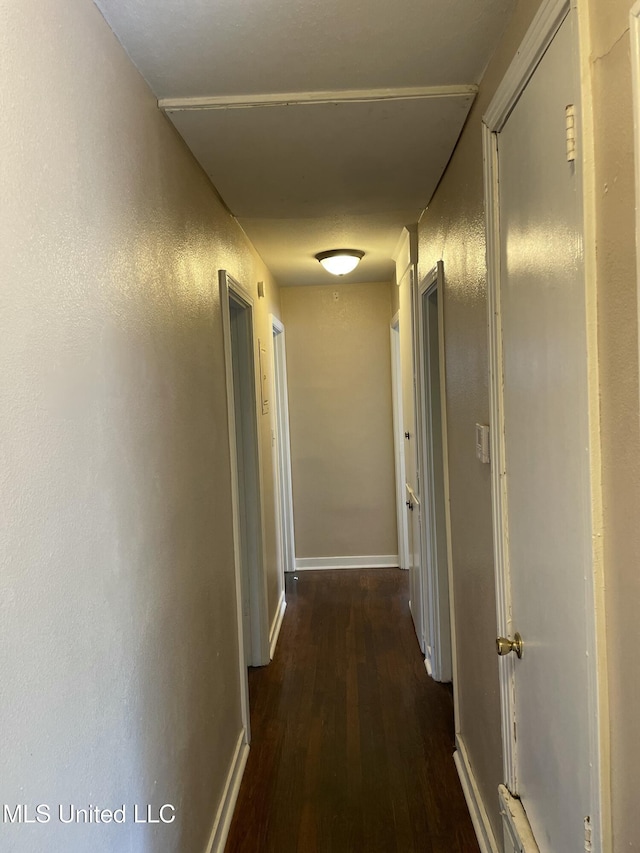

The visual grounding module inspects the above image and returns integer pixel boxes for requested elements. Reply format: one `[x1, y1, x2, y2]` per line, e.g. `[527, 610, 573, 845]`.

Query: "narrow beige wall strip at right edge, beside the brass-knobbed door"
[585, 0, 640, 851]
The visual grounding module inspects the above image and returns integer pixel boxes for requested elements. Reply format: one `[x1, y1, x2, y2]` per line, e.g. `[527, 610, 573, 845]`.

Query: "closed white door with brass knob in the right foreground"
[494, 4, 599, 853]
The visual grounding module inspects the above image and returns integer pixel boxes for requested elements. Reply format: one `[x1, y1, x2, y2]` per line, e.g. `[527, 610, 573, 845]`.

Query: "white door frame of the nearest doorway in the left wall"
[218, 270, 270, 724]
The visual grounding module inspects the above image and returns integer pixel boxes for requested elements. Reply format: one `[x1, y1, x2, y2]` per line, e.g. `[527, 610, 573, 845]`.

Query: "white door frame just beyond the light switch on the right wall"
[415, 261, 453, 681]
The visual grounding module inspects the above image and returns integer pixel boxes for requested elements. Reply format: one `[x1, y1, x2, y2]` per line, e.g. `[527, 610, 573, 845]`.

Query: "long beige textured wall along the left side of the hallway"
[0, 0, 277, 853]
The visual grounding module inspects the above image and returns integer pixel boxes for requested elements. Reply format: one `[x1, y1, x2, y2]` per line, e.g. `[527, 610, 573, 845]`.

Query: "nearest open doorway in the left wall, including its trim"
[219, 270, 270, 731]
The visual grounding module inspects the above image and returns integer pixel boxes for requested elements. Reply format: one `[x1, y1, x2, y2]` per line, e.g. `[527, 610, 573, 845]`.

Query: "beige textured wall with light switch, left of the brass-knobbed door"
[418, 0, 539, 839]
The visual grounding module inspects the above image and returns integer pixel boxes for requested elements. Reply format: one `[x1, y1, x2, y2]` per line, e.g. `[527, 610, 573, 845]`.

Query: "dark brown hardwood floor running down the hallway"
[226, 569, 479, 853]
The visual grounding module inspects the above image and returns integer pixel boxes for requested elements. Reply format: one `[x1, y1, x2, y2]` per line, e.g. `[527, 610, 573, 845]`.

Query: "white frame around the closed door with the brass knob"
[483, 0, 609, 853]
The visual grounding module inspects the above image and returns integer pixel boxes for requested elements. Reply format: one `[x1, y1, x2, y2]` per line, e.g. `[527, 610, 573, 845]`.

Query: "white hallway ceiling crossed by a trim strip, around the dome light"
[96, 0, 514, 285]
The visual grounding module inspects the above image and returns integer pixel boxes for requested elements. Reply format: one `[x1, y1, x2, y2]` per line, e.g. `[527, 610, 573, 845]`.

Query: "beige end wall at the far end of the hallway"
[280, 280, 398, 558]
